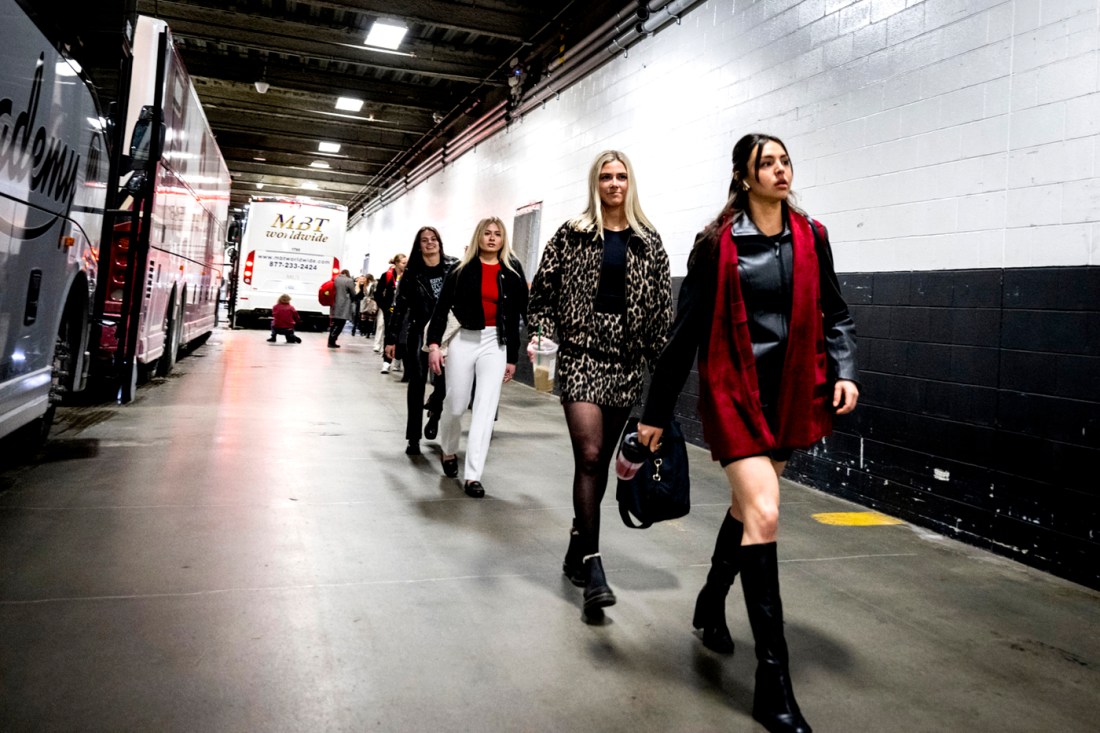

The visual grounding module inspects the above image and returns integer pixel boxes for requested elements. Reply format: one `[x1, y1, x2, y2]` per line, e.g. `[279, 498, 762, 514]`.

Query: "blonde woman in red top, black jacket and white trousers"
[426, 217, 527, 499]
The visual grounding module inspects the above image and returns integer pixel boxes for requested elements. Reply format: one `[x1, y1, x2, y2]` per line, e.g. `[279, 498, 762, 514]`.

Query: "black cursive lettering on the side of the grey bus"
[0, 53, 80, 209]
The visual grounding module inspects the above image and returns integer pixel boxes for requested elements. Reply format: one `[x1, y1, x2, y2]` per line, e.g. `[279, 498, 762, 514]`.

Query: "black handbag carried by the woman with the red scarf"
[615, 417, 691, 529]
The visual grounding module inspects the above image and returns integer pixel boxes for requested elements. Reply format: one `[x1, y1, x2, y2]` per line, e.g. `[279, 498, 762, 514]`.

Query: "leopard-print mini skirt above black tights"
[557, 313, 646, 407]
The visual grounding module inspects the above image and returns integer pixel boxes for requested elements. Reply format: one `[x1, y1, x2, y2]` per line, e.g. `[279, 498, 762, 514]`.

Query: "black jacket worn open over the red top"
[428, 258, 527, 364]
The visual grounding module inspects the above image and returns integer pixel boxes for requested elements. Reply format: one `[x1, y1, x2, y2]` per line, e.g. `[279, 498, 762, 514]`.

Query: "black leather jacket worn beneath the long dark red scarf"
[642, 215, 859, 425]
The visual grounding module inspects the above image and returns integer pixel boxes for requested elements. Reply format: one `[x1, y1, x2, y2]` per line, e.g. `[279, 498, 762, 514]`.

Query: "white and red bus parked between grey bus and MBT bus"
[98, 15, 231, 386]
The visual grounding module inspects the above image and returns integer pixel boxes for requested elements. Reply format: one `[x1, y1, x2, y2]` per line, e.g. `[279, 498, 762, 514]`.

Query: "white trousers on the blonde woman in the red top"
[439, 328, 508, 481]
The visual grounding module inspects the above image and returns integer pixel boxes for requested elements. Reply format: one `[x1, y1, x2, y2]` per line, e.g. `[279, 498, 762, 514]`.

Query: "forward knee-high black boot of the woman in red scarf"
[740, 543, 811, 733]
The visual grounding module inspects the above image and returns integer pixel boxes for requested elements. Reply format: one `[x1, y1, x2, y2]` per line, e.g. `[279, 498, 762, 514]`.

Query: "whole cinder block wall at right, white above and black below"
[352, 0, 1100, 587]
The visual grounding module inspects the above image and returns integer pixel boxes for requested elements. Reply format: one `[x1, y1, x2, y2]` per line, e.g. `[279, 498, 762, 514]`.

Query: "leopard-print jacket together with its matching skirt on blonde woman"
[527, 222, 672, 407]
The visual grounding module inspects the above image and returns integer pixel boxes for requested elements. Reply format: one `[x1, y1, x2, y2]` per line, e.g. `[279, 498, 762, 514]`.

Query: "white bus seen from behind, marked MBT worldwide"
[233, 197, 348, 330]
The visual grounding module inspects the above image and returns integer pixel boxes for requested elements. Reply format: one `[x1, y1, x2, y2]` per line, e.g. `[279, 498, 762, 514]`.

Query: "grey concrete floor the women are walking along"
[0, 331, 1100, 733]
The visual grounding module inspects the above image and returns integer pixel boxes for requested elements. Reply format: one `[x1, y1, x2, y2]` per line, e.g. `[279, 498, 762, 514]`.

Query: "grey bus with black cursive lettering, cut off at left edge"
[0, 0, 108, 437]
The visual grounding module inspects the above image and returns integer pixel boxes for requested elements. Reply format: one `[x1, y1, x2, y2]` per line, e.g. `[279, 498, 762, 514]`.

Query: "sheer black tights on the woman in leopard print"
[563, 402, 630, 555]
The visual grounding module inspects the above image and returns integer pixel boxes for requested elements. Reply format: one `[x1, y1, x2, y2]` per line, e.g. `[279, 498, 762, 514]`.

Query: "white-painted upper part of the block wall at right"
[349, 0, 1100, 275]
